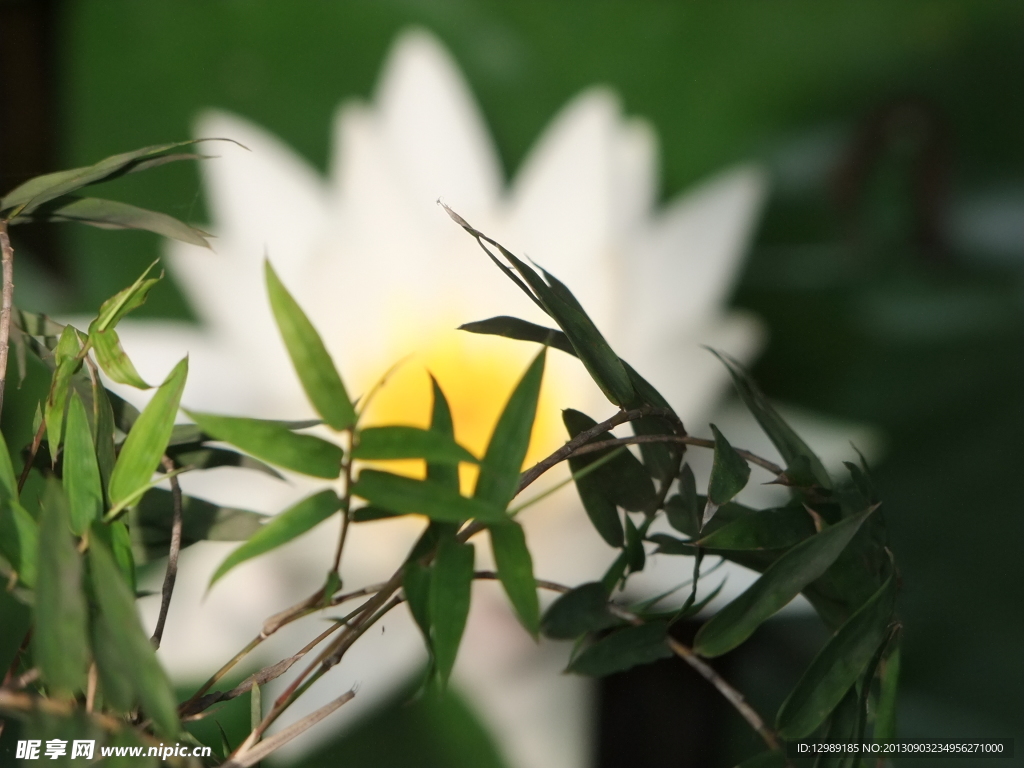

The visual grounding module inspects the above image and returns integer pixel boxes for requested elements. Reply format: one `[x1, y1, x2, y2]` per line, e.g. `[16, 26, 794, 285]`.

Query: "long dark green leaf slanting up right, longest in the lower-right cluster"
[693, 510, 873, 657]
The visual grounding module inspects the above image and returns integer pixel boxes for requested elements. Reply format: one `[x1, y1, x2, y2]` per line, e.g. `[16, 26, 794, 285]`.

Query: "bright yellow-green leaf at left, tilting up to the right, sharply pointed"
[110, 357, 188, 507]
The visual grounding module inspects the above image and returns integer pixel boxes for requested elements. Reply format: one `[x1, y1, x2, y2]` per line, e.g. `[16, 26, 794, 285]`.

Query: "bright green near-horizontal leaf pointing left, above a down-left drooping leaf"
[185, 410, 344, 479]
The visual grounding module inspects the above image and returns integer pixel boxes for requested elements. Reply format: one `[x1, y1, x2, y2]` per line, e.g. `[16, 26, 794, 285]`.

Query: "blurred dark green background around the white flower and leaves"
[0, 0, 1024, 766]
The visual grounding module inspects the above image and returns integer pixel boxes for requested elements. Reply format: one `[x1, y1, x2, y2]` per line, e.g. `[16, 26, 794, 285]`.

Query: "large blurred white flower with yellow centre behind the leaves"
[105, 27, 831, 768]
